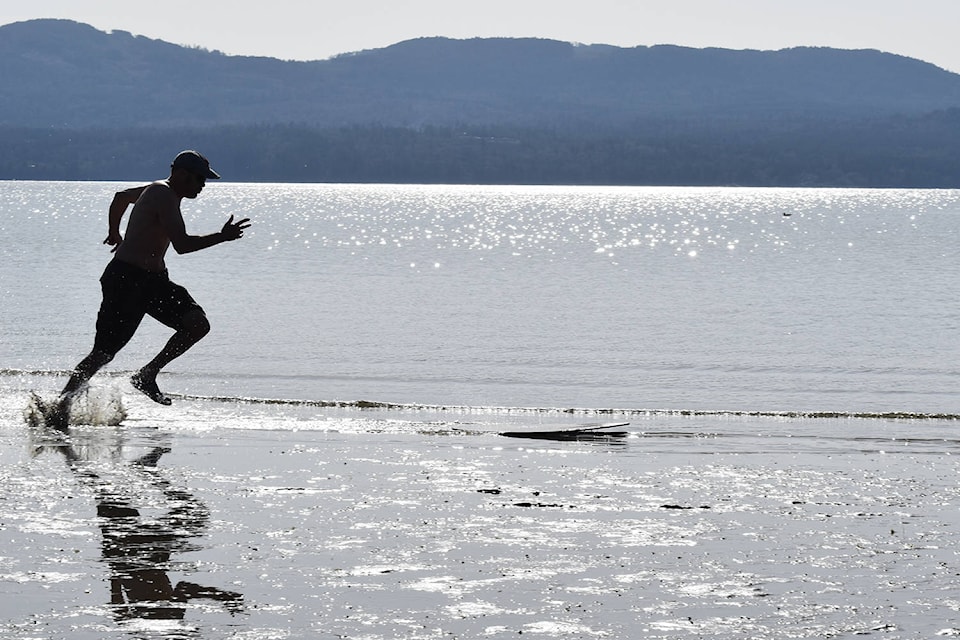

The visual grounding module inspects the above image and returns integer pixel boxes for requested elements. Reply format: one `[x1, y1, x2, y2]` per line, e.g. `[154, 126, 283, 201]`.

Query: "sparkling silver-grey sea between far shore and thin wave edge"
[0, 182, 960, 415]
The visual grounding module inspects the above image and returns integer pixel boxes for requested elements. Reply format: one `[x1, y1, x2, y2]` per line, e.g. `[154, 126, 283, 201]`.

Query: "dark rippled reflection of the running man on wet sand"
[38, 430, 243, 620]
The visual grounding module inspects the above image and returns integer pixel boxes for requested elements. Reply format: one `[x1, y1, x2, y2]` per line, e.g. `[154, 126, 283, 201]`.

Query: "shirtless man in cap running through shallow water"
[50, 151, 250, 426]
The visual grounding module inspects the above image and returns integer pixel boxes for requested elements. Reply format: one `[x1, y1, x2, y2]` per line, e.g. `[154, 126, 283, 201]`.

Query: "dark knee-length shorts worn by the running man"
[94, 260, 203, 355]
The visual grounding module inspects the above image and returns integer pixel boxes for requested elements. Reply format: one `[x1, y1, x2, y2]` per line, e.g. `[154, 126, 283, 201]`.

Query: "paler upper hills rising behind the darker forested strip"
[0, 20, 960, 129]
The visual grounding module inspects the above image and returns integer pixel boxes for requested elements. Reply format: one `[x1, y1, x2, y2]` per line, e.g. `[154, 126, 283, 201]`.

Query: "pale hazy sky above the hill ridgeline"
[0, 0, 960, 72]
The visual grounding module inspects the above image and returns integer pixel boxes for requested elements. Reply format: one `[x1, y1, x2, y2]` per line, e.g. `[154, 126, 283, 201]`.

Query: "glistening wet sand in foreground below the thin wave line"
[0, 398, 960, 640]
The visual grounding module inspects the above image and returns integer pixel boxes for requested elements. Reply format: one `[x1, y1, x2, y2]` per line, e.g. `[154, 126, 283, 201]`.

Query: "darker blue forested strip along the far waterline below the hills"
[0, 109, 960, 188]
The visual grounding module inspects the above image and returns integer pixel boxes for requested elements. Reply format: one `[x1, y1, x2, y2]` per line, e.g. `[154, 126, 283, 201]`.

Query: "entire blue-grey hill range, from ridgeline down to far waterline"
[0, 20, 960, 188]
